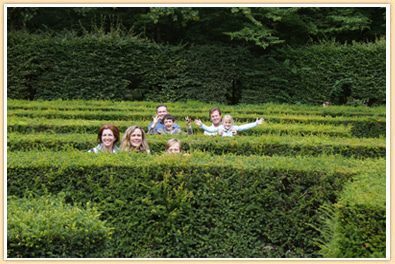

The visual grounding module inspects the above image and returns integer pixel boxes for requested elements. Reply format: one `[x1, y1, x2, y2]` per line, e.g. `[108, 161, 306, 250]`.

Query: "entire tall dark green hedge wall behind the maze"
[7, 32, 386, 105]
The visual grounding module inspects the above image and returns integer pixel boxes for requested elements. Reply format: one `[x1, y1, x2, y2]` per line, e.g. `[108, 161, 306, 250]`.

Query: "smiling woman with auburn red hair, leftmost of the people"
[88, 124, 119, 153]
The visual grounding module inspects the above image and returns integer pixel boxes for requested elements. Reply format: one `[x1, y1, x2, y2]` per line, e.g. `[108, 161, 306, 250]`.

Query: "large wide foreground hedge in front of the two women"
[7, 152, 385, 257]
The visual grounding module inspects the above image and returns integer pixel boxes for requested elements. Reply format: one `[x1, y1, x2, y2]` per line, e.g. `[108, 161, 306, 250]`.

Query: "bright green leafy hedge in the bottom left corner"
[7, 195, 112, 258]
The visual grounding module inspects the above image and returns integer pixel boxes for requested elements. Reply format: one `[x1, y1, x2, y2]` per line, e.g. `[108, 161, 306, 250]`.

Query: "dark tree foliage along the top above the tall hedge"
[7, 7, 385, 49]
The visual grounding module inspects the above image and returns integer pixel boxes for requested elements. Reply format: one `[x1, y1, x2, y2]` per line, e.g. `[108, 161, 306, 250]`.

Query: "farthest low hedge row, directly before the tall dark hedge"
[7, 99, 385, 117]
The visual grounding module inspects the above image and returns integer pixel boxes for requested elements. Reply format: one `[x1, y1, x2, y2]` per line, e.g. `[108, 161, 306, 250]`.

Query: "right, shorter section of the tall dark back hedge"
[241, 40, 386, 105]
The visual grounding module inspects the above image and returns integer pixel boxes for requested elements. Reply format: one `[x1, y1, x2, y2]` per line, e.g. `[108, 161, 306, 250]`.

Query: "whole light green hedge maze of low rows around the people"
[7, 99, 386, 258]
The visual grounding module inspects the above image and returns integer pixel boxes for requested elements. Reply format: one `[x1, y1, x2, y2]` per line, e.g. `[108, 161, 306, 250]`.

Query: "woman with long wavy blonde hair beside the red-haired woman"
[121, 126, 150, 154]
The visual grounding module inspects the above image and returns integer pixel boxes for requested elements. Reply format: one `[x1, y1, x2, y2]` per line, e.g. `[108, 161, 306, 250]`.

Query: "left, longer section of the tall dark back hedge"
[7, 32, 246, 103]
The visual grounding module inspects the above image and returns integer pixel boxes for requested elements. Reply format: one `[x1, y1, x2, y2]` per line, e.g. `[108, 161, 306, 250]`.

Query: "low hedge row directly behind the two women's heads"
[7, 117, 352, 137]
